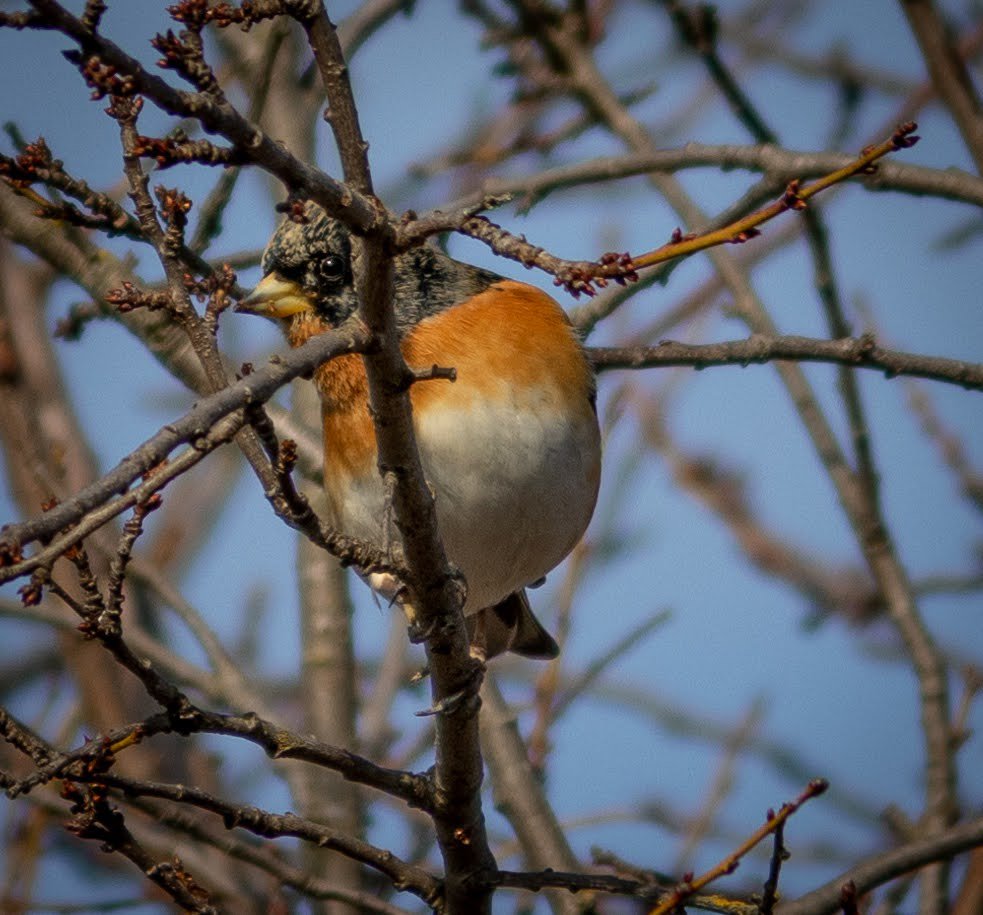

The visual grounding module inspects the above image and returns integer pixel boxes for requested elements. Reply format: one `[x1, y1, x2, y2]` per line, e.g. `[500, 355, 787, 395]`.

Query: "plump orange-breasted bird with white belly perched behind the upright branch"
[237, 201, 601, 661]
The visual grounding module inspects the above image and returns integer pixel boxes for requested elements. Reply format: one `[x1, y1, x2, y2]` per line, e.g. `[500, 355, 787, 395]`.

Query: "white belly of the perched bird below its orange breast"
[328, 398, 600, 613]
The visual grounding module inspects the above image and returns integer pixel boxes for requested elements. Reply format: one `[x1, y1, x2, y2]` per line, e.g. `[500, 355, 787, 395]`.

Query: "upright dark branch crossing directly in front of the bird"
[294, 0, 495, 913]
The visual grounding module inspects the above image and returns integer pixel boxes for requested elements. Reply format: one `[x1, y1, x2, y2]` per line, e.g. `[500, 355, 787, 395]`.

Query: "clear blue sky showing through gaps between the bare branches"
[0, 0, 983, 908]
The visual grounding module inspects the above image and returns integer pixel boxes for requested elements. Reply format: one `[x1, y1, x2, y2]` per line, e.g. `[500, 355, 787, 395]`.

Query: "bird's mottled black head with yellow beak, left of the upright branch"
[236, 203, 358, 339]
